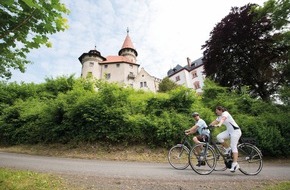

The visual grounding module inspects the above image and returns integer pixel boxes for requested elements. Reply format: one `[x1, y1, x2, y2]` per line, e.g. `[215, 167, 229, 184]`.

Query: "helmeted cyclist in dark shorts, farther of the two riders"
[185, 112, 210, 166]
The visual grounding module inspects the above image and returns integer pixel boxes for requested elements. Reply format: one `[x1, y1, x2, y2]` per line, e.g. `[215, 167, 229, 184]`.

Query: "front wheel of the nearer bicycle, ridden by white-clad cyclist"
[189, 143, 216, 175]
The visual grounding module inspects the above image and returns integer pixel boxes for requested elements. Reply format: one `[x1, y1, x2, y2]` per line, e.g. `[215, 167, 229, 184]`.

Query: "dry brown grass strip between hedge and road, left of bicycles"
[0, 144, 168, 163]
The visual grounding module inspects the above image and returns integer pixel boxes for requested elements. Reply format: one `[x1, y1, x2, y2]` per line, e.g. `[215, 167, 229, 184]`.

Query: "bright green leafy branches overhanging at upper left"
[0, 0, 69, 79]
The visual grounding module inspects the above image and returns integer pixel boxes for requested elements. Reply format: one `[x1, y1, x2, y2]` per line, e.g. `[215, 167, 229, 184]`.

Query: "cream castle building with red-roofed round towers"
[79, 33, 161, 92]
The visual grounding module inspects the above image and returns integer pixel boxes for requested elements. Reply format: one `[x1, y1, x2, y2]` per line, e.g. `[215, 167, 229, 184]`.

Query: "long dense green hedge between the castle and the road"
[0, 77, 290, 156]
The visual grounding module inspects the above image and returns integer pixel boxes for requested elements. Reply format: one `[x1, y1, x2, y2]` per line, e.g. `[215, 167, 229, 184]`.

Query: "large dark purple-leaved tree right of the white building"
[202, 4, 289, 101]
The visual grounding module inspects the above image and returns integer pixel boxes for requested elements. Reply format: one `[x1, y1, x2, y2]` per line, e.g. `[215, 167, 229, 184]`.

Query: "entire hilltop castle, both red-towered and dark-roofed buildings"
[79, 30, 205, 93]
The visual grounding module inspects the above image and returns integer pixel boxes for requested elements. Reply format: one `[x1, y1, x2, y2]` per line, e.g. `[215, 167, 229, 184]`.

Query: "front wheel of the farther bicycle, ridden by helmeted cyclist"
[168, 144, 189, 170]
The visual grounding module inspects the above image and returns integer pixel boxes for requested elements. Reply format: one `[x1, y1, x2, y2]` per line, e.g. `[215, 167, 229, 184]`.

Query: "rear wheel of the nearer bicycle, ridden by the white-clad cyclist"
[238, 143, 263, 175]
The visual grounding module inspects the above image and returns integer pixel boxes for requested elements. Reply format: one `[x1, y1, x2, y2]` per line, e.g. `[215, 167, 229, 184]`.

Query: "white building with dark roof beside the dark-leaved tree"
[167, 58, 205, 93]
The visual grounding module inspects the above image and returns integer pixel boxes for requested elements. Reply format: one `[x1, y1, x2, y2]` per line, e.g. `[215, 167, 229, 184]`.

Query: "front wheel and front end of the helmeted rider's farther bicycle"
[167, 134, 193, 170]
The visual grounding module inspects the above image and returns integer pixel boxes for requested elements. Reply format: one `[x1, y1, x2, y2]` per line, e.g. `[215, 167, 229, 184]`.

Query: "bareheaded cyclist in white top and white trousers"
[210, 106, 242, 172]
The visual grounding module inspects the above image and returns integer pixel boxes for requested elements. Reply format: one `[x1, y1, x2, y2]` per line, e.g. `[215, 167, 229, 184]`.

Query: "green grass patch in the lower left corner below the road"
[0, 168, 72, 190]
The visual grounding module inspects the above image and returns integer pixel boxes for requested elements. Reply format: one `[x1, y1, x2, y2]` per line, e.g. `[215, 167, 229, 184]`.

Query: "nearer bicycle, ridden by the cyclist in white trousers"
[189, 126, 263, 175]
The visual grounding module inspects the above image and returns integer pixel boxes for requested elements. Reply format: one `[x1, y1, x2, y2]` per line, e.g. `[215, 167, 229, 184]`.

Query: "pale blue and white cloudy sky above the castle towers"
[9, 0, 266, 83]
